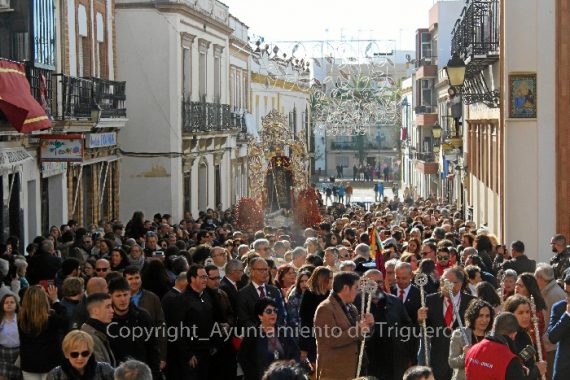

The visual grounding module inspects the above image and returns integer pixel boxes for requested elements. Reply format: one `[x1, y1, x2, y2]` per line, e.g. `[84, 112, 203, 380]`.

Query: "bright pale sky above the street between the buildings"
[221, 0, 437, 50]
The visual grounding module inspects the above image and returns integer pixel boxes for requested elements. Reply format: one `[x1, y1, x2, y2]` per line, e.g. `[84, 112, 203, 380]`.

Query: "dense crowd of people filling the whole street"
[0, 193, 570, 380]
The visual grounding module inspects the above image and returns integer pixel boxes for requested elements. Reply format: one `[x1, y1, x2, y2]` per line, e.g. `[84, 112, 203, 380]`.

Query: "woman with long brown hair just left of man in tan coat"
[299, 266, 333, 364]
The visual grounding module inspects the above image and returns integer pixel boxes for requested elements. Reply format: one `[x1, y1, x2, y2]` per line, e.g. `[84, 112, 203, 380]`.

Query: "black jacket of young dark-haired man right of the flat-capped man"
[107, 303, 160, 379]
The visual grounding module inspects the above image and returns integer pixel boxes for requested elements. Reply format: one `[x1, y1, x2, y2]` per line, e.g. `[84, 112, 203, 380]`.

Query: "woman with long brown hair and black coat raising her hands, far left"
[18, 285, 69, 380]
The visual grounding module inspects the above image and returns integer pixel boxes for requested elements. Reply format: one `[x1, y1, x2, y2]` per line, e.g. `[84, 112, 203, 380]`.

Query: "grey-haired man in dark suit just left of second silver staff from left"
[391, 262, 422, 365]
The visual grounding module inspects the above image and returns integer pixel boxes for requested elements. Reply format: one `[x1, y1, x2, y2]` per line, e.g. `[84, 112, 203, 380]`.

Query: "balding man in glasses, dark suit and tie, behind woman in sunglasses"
[237, 257, 286, 327]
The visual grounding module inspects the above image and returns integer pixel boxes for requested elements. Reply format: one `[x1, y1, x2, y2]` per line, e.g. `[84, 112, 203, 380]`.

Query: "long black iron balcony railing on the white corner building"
[182, 100, 232, 133]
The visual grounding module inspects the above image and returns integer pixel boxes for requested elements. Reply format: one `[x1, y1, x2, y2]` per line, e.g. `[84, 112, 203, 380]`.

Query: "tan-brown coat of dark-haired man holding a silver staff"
[314, 295, 362, 380]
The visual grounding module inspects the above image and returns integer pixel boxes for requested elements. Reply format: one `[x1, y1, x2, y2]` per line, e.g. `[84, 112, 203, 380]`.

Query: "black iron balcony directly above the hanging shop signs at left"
[54, 74, 127, 120]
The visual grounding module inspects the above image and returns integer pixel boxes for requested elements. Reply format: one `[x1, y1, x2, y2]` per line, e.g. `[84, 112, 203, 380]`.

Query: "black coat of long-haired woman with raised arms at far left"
[18, 302, 69, 373]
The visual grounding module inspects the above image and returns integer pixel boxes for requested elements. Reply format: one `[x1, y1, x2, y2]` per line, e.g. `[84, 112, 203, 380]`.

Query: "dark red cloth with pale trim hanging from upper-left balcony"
[0, 60, 51, 133]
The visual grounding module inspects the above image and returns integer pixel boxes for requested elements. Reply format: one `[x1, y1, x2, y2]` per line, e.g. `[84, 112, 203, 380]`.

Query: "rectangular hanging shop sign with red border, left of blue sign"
[40, 135, 83, 162]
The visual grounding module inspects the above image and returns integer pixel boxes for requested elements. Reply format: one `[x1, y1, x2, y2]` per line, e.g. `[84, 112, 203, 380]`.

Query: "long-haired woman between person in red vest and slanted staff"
[503, 294, 547, 380]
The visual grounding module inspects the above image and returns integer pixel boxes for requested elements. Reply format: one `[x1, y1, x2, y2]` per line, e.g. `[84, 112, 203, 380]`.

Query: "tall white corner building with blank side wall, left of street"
[116, 0, 239, 220]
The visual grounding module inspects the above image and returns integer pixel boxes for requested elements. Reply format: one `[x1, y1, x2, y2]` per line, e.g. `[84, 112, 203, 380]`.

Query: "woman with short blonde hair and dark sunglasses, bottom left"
[47, 330, 114, 380]
